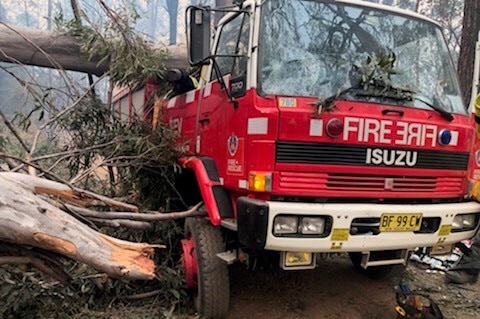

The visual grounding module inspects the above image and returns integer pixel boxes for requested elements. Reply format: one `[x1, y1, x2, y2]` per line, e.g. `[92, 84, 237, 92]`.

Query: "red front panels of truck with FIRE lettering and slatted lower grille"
[274, 98, 474, 199]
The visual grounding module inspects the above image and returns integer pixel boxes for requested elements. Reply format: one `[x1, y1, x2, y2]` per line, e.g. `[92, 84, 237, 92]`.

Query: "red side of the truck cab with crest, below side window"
[165, 78, 278, 196]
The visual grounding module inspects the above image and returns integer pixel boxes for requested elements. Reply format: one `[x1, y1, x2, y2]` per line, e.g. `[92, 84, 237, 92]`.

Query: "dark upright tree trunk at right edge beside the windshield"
[458, 0, 480, 105]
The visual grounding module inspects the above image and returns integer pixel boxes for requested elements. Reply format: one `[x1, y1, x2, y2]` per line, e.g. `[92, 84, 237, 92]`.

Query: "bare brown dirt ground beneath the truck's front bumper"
[228, 255, 480, 319]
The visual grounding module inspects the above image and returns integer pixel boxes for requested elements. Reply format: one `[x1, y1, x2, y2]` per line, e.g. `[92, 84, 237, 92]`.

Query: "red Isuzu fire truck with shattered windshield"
[115, 0, 480, 318]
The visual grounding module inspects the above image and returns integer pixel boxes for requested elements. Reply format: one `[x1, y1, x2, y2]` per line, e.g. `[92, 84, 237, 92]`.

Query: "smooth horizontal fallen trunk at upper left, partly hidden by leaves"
[0, 23, 189, 76]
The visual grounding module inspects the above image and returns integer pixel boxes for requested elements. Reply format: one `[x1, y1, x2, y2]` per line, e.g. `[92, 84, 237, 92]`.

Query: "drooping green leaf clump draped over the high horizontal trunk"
[55, 6, 167, 86]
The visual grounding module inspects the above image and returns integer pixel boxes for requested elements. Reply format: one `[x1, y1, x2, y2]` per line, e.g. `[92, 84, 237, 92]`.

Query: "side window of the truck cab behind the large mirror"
[211, 13, 250, 80]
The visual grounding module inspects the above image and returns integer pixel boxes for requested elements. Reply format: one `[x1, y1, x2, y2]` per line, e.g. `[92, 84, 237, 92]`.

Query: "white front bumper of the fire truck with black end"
[237, 197, 480, 252]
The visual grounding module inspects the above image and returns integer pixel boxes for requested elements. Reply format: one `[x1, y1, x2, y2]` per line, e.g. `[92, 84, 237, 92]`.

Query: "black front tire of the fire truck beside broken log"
[185, 218, 230, 318]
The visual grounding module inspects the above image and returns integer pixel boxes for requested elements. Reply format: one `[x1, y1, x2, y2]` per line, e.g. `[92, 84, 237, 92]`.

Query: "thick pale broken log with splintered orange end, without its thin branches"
[0, 173, 160, 279]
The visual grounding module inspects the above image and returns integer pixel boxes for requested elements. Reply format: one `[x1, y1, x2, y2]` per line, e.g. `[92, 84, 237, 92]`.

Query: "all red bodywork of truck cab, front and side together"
[166, 84, 479, 205]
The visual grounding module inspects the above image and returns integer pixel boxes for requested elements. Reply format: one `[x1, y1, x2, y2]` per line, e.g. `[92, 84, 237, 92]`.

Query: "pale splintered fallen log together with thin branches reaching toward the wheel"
[0, 172, 203, 283]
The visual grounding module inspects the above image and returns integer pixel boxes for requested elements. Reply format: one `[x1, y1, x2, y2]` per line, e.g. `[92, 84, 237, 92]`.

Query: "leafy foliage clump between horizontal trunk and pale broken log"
[50, 97, 180, 209]
